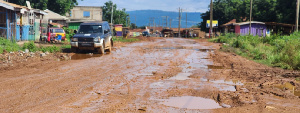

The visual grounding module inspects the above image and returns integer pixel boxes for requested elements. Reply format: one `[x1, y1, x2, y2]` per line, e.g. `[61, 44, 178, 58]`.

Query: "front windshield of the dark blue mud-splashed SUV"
[78, 25, 102, 34]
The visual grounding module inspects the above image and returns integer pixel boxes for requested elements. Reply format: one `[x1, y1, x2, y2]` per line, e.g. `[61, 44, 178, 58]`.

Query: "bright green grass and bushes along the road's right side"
[210, 32, 300, 70]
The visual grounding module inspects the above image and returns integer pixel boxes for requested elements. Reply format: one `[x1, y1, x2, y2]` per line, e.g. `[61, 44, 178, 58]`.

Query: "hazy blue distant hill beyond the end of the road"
[127, 10, 202, 28]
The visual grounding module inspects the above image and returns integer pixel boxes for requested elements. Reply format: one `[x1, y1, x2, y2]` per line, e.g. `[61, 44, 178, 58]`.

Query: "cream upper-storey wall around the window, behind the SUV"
[66, 6, 103, 21]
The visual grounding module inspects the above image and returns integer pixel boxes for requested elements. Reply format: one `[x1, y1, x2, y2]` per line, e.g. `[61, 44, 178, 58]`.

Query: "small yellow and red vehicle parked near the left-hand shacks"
[48, 28, 66, 41]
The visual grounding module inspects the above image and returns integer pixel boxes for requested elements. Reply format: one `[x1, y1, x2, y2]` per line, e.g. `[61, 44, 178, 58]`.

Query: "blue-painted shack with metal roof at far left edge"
[0, 0, 47, 41]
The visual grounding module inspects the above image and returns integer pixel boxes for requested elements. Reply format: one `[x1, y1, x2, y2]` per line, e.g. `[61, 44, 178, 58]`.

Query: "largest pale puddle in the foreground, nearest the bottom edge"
[161, 96, 222, 109]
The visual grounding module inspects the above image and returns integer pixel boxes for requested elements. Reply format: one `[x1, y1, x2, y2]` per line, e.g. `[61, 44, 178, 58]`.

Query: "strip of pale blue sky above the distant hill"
[77, 0, 210, 13]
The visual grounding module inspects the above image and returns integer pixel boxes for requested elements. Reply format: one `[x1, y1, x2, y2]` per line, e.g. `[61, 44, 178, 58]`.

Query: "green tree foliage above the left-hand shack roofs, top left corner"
[9, 0, 78, 15]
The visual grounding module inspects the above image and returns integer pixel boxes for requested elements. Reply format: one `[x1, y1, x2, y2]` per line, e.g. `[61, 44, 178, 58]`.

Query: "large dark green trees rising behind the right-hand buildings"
[199, 0, 297, 31]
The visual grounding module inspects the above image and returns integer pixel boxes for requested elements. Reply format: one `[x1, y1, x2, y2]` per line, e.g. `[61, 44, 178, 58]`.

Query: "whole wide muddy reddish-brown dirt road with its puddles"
[0, 38, 300, 113]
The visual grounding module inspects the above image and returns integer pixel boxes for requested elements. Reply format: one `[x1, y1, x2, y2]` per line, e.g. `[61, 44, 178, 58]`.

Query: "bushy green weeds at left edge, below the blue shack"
[0, 37, 20, 54]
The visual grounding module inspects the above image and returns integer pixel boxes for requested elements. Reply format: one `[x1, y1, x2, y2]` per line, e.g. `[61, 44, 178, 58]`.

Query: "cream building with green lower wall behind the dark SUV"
[66, 6, 102, 30]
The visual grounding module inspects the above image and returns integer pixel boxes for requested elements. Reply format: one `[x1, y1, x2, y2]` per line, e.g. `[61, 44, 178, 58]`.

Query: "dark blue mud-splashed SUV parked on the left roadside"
[71, 21, 113, 54]
